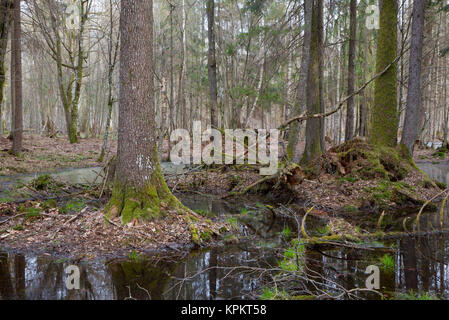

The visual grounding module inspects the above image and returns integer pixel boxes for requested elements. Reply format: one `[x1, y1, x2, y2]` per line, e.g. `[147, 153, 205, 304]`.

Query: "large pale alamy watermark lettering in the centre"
[170, 121, 279, 176]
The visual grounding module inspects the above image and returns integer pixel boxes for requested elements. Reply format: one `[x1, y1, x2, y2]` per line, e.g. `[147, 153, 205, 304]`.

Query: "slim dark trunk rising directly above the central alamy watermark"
[206, 0, 218, 128]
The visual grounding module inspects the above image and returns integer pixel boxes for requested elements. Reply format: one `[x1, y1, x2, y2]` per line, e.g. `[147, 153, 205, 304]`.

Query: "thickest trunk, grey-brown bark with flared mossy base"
[105, 0, 181, 223]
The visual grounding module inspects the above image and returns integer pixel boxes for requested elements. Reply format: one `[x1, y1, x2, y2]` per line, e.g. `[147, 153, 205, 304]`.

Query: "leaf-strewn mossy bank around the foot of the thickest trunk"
[0, 175, 227, 258]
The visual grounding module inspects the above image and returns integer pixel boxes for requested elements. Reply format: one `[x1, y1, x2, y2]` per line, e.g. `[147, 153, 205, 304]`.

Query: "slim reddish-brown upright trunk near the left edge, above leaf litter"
[11, 0, 23, 156]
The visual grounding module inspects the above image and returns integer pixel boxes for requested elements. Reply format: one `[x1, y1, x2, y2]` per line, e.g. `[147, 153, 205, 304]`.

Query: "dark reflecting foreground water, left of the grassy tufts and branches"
[0, 248, 272, 300]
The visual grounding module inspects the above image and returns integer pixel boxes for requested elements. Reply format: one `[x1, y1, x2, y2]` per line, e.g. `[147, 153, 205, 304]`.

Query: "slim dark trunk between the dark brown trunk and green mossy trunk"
[345, 0, 357, 141]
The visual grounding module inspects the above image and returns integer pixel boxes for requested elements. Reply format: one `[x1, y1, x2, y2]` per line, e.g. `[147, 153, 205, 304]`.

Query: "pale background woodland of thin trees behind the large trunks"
[0, 0, 449, 153]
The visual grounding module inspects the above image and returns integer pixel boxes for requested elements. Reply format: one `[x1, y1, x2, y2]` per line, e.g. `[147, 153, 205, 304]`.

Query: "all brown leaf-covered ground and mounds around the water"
[0, 136, 446, 257]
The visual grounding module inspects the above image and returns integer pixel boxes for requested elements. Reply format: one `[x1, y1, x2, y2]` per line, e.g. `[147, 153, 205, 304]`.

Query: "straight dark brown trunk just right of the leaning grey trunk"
[302, 0, 324, 163]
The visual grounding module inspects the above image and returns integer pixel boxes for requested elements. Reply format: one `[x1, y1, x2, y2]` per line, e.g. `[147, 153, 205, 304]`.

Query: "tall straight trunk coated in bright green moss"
[370, 0, 398, 147]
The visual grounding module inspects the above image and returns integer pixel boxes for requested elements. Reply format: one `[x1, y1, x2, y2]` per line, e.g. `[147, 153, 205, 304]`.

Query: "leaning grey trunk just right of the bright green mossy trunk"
[401, 0, 426, 156]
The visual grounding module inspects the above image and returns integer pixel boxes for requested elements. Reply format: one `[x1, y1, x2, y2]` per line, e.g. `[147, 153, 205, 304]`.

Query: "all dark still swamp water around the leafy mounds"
[0, 163, 449, 300]
